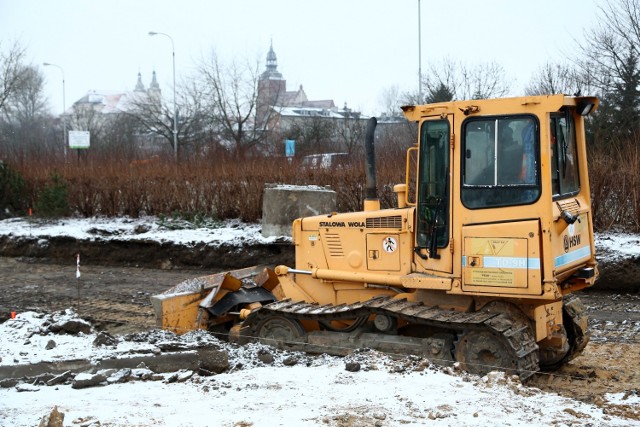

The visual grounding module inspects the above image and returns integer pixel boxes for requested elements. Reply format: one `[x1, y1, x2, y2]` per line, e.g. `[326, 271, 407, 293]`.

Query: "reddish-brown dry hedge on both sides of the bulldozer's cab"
[16, 138, 640, 232]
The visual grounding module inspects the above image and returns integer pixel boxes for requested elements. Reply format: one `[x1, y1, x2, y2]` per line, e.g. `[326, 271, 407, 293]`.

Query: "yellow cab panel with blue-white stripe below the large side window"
[462, 221, 542, 295]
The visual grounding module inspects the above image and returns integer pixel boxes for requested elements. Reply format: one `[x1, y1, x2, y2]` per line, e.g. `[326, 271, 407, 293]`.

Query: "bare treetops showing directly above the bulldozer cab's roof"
[423, 58, 509, 102]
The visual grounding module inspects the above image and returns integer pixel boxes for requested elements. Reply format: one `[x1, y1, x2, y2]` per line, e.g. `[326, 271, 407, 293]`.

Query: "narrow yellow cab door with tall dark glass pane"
[414, 115, 454, 273]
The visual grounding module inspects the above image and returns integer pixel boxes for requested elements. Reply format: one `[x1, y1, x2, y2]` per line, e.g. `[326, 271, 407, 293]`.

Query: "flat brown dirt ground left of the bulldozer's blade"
[0, 257, 216, 333]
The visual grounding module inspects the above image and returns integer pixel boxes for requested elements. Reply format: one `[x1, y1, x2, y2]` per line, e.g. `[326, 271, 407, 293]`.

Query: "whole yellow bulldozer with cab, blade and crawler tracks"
[152, 95, 598, 379]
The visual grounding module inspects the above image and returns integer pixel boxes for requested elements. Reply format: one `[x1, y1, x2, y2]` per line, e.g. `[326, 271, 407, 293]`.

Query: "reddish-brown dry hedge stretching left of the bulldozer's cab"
[11, 148, 404, 222]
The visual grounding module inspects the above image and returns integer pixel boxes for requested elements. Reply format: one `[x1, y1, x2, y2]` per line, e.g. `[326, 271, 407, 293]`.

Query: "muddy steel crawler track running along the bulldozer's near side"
[243, 297, 539, 379]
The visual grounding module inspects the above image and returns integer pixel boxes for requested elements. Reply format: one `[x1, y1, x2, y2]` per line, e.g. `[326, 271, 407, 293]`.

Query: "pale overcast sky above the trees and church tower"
[0, 0, 605, 114]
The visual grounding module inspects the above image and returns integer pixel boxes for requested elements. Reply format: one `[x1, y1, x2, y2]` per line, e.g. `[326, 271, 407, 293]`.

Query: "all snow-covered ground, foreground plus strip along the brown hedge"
[0, 218, 640, 427]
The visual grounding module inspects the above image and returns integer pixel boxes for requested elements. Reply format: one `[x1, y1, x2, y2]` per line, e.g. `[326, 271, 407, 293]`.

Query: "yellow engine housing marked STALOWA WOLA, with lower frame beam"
[292, 208, 414, 304]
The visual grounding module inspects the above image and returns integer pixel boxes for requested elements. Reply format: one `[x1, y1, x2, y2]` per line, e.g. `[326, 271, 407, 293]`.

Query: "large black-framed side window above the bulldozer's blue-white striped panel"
[461, 116, 540, 209]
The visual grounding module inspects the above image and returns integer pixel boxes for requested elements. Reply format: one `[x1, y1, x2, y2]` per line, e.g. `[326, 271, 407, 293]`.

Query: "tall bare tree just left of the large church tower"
[197, 52, 273, 158]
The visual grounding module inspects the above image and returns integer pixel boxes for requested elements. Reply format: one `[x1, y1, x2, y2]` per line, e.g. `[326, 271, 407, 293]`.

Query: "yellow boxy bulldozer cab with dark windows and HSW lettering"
[404, 95, 597, 299]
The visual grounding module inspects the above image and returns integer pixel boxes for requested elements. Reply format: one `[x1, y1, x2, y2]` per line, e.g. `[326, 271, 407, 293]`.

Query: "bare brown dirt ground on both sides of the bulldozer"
[0, 257, 640, 419]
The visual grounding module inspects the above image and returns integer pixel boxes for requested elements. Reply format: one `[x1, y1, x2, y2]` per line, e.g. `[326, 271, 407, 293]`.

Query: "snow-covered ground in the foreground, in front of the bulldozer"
[0, 310, 640, 427]
